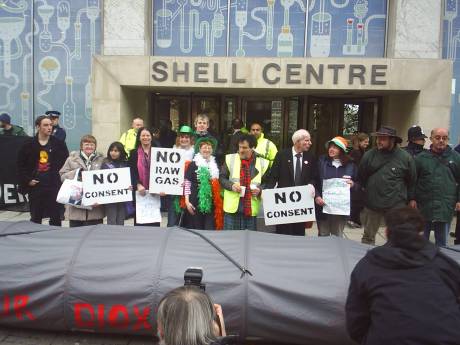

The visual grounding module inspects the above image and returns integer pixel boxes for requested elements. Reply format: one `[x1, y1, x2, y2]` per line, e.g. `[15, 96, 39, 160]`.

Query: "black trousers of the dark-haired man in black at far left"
[29, 186, 61, 226]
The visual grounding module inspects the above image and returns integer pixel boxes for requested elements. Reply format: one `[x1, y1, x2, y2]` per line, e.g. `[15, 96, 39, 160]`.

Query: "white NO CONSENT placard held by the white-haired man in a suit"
[262, 186, 316, 225]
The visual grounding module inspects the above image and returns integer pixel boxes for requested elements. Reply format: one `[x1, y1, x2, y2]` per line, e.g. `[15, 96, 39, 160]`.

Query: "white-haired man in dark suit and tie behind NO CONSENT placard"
[269, 129, 316, 236]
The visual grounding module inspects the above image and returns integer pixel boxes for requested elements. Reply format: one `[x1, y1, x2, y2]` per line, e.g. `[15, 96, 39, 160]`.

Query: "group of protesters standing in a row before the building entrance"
[7, 111, 460, 246]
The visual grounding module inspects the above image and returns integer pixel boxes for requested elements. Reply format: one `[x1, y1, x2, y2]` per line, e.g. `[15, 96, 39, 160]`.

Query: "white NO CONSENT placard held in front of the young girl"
[81, 168, 133, 206]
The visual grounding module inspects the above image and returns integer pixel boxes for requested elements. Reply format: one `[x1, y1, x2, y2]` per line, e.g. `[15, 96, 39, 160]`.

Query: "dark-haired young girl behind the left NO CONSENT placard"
[102, 141, 128, 225]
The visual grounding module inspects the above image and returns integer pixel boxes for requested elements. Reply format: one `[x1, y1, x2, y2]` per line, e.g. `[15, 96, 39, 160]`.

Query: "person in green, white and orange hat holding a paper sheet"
[315, 137, 358, 237]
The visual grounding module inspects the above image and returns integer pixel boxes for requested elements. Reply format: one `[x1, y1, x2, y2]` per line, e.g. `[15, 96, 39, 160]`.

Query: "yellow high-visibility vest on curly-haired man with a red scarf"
[224, 153, 269, 217]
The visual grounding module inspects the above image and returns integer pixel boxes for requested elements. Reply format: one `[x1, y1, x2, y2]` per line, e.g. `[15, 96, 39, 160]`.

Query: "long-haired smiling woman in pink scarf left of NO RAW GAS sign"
[128, 127, 160, 226]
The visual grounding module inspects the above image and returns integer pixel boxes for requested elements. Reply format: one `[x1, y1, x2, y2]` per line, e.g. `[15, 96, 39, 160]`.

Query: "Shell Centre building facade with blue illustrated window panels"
[0, 0, 460, 153]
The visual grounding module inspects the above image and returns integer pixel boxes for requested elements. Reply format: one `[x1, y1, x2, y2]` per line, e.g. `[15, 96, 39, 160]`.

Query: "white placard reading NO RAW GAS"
[149, 147, 185, 195]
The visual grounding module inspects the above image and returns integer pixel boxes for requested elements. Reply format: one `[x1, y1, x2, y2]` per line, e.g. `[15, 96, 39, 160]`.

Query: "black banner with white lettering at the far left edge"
[0, 135, 29, 211]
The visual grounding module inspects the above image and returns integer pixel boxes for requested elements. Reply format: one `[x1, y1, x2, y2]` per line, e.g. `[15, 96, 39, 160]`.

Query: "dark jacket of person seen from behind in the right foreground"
[346, 225, 460, 345]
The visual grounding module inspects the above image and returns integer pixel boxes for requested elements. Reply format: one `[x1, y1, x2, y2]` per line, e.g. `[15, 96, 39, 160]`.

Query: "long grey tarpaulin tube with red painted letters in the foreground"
[0, 222, 460, 344]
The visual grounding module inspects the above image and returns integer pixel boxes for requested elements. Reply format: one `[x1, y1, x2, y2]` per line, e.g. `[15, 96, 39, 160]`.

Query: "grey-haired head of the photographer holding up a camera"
[158, 286, 220, 345]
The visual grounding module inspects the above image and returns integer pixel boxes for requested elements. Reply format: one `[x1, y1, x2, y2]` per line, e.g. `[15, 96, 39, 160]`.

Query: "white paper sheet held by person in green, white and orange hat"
[323, 178, 350, 216]
